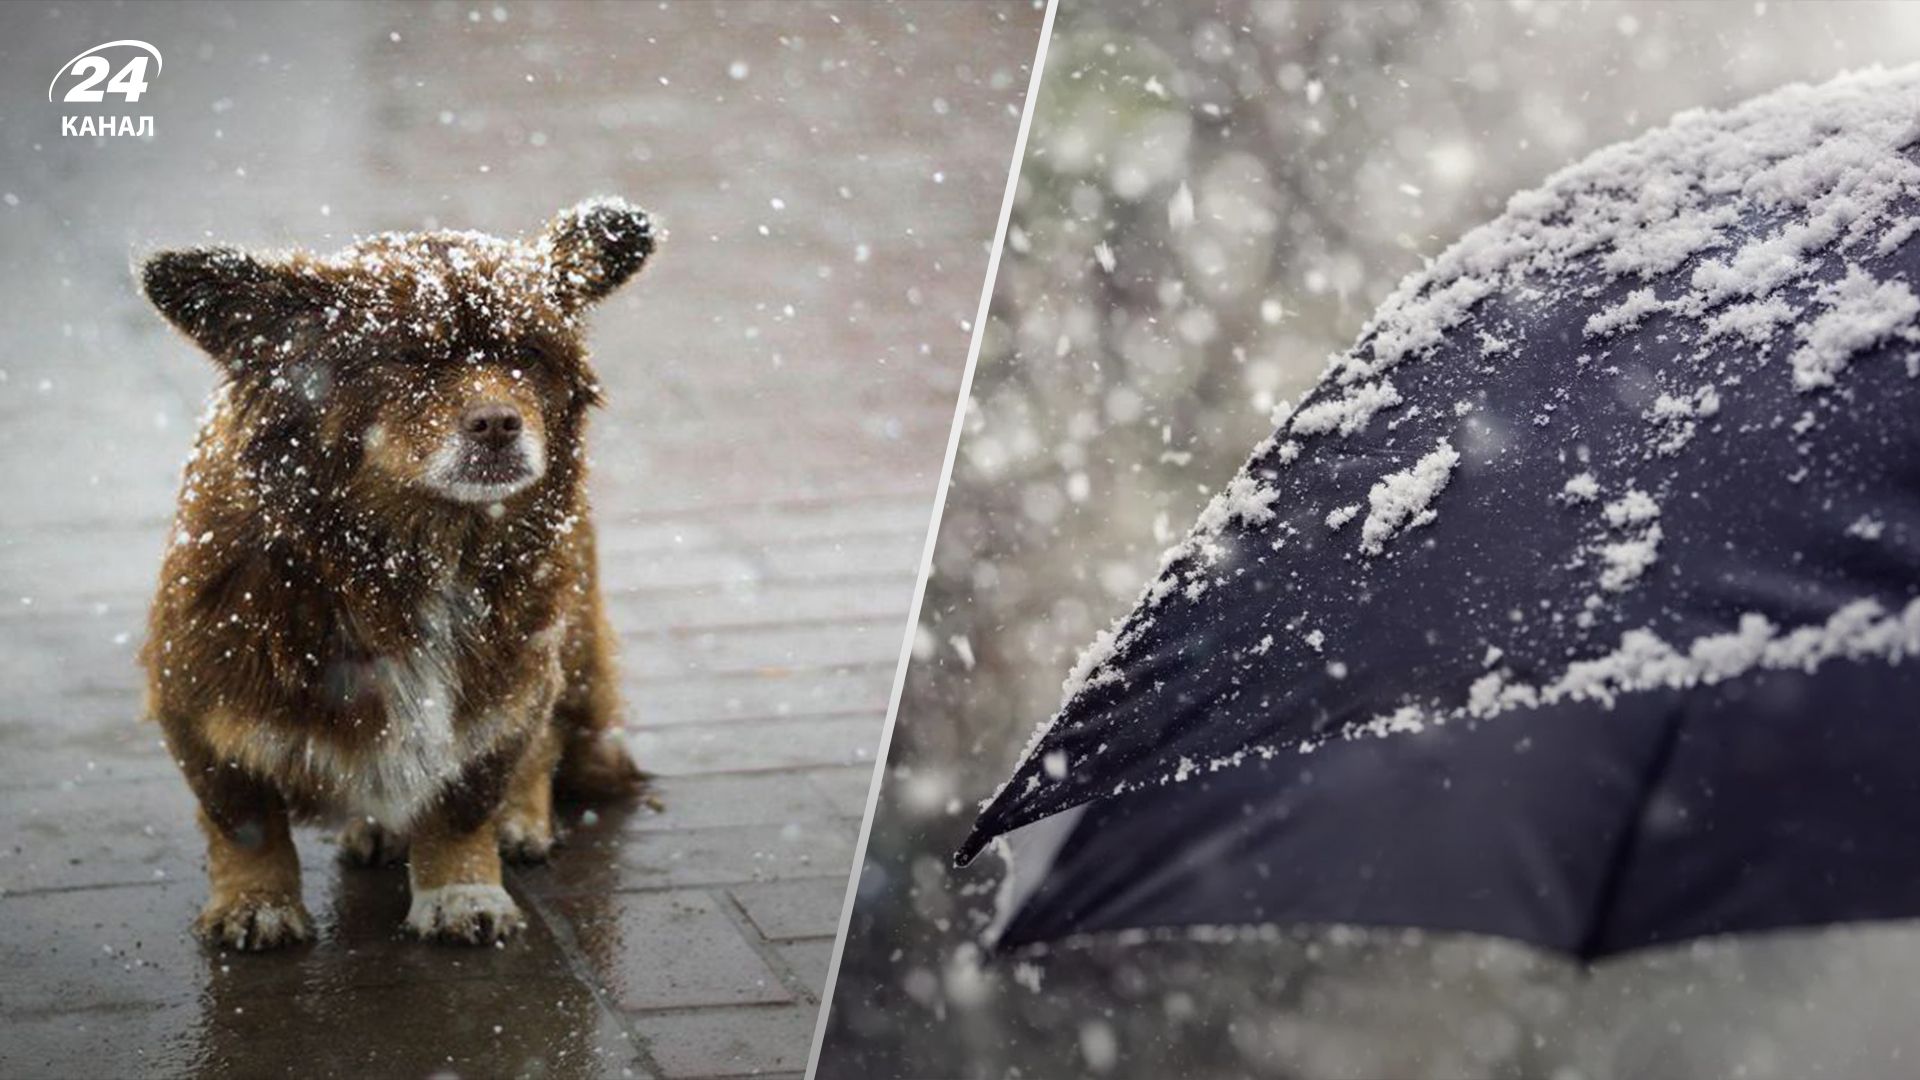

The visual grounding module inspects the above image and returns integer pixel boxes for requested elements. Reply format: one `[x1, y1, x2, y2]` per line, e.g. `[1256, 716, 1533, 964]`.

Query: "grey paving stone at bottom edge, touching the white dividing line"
[632, 1005, 816, 1076]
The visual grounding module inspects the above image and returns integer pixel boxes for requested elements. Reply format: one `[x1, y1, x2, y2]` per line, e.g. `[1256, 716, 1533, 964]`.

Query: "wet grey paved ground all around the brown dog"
[0, 4, 1041, 1076]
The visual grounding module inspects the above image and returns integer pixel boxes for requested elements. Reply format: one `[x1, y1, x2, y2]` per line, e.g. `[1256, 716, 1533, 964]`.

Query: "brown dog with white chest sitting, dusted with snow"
[142, 200, 653, 949]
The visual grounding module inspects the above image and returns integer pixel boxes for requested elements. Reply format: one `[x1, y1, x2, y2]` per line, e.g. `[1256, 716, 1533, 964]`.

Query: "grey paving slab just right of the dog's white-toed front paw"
[553, 890, 795, 1009]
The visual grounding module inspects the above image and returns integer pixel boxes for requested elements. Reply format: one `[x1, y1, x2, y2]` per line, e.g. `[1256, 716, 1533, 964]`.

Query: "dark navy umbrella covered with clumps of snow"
[960, 67, 1920, 957]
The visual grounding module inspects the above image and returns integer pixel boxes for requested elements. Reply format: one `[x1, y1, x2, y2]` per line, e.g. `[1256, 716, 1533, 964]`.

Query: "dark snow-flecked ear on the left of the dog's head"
[140, 248, 328, 375]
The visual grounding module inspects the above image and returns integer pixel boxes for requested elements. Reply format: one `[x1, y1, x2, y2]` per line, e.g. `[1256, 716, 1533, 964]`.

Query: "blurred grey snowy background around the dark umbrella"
[820, 0, 1920, 1080]
